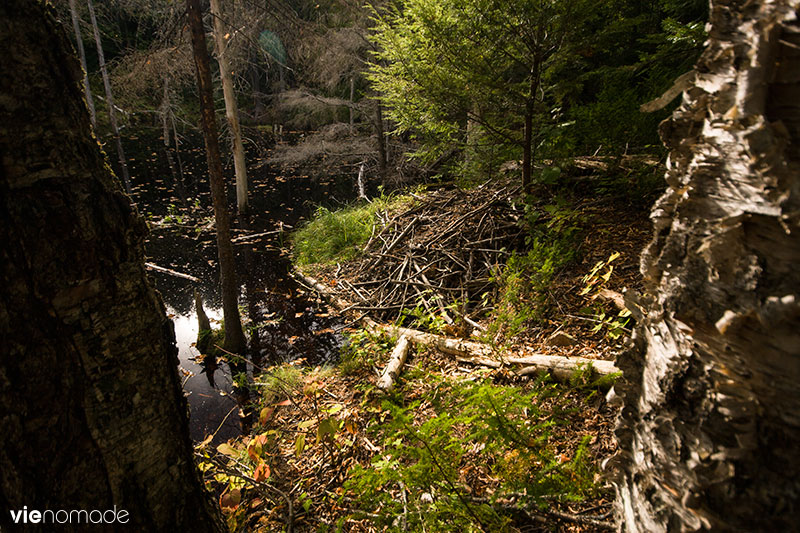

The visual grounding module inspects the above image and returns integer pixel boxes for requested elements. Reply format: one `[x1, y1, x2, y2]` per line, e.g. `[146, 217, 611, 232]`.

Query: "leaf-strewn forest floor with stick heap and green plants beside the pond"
[192, 154, 661, 532]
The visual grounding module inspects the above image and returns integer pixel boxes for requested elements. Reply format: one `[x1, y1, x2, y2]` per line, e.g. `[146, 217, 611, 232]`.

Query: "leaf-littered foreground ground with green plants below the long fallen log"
[198, 333, 609, 531]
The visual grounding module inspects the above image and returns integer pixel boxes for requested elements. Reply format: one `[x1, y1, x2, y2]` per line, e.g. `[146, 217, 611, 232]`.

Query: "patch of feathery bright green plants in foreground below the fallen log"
[344, 369, 599, 531]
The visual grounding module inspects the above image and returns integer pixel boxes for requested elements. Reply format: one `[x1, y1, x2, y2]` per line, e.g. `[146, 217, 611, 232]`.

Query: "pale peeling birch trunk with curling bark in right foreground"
[616, 0, 800, 532]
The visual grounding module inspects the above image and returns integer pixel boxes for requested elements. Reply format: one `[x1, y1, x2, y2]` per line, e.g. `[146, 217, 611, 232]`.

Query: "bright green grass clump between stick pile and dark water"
[293, 195, 412, 265]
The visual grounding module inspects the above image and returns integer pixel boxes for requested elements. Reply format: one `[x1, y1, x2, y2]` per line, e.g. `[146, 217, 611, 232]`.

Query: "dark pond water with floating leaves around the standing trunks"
[129, 130, 355, 442]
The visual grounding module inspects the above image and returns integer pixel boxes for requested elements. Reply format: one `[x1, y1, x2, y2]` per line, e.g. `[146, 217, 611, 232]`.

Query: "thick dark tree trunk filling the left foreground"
[0, 0, 222, 532]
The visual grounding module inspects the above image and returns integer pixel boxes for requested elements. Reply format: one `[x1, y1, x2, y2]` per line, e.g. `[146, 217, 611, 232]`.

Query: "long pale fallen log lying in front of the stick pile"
[292, 269, 619, 381]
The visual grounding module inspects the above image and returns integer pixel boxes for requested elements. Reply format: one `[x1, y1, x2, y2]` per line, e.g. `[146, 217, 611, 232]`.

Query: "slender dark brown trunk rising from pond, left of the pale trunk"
[186, 0, 247, 353]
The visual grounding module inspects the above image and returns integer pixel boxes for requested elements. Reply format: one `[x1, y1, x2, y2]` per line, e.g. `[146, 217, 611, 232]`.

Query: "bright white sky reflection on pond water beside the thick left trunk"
[167, 306, 241, 442]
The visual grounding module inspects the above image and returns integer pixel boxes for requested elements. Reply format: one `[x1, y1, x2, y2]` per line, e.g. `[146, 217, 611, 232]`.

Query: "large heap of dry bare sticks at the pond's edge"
[330, 181, 524, 327]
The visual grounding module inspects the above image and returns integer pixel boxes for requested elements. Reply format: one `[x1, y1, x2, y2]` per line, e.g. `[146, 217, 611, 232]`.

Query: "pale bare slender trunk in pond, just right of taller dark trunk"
[211, 0, 247, 215]
